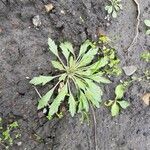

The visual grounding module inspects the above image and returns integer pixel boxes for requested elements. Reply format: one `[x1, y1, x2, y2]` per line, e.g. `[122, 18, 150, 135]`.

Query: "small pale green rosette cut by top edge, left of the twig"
[105, 0, 122, 18]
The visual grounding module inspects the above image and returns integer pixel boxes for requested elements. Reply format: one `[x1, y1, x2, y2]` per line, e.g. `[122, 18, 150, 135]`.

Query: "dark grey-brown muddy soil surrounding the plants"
[0, 0, 150, 150]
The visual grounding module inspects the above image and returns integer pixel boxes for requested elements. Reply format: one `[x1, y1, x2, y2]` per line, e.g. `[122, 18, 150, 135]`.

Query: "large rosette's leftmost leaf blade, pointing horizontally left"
[29, 76, 55, 85]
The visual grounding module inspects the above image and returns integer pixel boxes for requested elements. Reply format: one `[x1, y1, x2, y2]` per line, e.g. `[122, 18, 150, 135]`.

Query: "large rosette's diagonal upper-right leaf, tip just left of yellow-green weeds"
[78, 47, 98, 67]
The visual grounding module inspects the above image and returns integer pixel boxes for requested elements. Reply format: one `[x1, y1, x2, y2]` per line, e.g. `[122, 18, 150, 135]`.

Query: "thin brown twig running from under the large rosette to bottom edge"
[91, 105, 98, 150]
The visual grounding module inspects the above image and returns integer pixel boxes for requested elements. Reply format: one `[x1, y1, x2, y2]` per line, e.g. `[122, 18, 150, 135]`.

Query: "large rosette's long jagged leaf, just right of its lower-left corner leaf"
[48, 84, 68, 116]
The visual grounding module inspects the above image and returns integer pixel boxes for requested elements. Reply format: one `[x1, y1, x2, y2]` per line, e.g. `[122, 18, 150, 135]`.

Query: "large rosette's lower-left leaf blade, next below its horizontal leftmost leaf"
[38, 89, 54, 110]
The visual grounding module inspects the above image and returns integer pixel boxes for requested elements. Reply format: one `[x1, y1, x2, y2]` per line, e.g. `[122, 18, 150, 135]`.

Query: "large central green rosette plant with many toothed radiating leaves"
[30, 38, 110, 119]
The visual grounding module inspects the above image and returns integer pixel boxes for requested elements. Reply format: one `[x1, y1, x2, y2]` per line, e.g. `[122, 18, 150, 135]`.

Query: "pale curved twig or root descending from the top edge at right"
[127, 0, 141, 53]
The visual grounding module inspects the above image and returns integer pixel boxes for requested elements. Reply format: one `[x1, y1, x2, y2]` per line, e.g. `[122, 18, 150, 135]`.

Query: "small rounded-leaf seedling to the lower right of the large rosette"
[105, 84, 130, 117]
